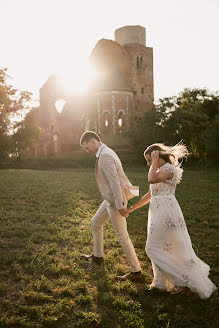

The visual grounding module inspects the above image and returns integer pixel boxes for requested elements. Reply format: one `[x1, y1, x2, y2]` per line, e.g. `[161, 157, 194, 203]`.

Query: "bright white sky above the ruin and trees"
[0, 0, 219, 104]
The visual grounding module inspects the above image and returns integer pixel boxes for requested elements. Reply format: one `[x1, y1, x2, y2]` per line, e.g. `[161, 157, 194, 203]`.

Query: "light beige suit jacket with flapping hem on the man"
[96, 145, 139, 210]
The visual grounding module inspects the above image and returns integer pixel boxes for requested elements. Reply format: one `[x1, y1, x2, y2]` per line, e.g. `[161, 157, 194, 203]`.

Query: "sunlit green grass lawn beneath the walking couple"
[0, 167, 219, 328]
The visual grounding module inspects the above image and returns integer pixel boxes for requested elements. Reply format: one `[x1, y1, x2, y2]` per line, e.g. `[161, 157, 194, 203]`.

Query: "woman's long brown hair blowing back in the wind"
[144, 141, 189, 166]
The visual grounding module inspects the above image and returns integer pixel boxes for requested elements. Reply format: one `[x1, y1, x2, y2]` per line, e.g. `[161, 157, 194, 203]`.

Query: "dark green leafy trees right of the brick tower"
[129, 89, 219, 163]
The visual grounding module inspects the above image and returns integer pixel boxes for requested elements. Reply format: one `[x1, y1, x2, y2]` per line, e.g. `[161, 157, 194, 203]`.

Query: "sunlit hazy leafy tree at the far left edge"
[0, 68, 31, 158]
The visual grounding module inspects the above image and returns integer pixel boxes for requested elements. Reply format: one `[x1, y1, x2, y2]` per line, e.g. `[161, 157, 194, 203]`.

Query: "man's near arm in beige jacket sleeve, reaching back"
[101, 154, 125, 210]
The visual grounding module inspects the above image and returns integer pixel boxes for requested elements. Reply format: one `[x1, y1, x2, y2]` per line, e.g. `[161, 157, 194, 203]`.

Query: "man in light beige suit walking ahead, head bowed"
[80, 131, 143, 281]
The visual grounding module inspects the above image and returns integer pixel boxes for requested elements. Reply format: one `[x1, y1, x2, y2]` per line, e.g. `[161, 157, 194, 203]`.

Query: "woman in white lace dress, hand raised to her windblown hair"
[126, 143, 217, 299]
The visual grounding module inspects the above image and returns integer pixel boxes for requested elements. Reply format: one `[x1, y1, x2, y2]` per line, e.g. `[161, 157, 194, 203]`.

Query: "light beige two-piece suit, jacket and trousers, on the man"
[91, 145, 141, 272]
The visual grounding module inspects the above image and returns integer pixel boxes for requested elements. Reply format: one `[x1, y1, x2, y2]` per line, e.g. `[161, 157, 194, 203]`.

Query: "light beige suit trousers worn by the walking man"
[91, 200, 141, 272]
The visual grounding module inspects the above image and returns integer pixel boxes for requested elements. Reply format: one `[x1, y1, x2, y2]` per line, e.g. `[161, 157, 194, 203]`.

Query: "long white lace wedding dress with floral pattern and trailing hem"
[146, 163, 217, 299]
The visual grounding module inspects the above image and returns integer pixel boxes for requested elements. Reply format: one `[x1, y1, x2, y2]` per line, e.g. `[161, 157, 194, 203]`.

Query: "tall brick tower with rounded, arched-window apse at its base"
[90, 26, 154, 135]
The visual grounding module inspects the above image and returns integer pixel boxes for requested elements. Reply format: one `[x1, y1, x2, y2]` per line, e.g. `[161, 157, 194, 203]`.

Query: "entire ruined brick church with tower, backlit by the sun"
[34, 26, 154, 156]
